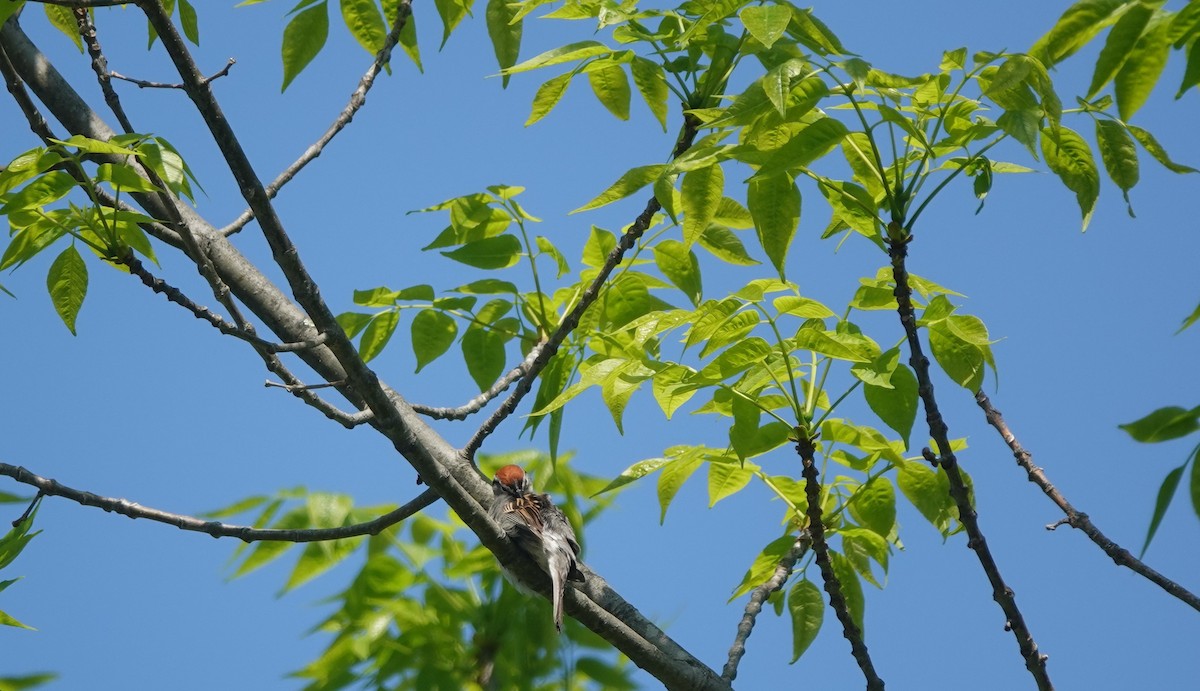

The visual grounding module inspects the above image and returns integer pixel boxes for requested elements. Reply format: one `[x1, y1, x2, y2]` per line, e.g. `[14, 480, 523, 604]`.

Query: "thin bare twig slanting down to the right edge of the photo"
[976, 391, 1200, 611]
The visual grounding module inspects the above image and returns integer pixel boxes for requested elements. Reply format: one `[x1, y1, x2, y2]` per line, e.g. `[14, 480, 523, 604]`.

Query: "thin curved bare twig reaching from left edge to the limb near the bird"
[0, 463, 438, 542]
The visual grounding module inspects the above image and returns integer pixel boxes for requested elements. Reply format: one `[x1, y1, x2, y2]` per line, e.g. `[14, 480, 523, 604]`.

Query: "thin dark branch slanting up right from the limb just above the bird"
[463, 115, 700, 458]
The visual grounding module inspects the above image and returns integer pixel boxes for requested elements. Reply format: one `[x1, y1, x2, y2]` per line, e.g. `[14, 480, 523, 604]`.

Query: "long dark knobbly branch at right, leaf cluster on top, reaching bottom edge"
[888, 229, 1054, 691]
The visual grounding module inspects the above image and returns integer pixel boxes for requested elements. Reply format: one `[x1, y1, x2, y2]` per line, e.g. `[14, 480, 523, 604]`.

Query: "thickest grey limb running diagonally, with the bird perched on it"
[0, 22, 728, 690]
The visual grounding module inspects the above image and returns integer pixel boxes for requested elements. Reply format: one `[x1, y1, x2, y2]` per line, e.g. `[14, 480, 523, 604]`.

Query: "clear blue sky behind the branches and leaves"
[0, 1, 1200, 690]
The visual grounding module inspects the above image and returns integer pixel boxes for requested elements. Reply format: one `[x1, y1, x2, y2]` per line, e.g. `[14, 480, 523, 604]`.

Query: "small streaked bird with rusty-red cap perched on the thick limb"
[488, 465, 584, 633]
